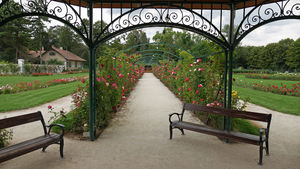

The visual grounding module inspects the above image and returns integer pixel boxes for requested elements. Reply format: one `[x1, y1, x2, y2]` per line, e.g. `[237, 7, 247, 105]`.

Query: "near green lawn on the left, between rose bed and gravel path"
[0, 81, 81, 112]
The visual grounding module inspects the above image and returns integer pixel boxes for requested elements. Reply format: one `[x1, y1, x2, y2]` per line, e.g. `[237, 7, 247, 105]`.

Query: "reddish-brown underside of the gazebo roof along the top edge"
[56, 0, 282, 10]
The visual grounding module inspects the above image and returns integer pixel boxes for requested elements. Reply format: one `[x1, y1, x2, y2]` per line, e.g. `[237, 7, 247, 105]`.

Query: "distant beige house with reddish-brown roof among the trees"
[28, 45, 86, 70]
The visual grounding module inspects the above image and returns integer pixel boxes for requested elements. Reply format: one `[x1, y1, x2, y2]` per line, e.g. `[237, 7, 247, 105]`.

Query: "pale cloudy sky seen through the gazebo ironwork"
[51, 0, 300, 46]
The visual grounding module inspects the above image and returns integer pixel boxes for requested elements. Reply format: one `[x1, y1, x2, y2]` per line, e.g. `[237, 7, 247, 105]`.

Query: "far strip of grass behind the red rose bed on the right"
[233, 74, 300, 88]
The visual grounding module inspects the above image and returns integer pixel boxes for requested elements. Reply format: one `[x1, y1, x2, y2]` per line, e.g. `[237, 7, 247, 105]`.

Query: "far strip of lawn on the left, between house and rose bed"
[0, 73, 88, 86]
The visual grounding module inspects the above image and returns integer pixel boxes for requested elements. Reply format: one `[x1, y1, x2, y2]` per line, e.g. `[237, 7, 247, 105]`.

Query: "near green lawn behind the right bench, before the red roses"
[233, 86, 300, 116]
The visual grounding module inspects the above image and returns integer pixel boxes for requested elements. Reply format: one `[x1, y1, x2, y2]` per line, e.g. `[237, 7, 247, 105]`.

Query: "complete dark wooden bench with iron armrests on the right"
[169, 103, 272, 165]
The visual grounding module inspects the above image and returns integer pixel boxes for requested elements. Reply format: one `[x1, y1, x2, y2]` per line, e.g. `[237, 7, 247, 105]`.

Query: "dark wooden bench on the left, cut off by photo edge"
[0, 111, 64, 163]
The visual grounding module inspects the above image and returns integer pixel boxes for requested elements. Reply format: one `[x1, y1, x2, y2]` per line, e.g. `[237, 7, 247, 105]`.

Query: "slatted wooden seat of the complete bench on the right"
[171, 121, 265, 145]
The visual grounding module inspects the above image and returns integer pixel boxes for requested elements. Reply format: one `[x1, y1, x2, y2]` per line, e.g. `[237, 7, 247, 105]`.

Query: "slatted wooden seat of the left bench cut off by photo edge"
[0, 134, 60, 163]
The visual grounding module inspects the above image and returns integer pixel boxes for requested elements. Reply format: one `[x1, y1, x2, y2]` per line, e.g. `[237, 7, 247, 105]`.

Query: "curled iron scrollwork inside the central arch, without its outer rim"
[96, 4, 226, 46]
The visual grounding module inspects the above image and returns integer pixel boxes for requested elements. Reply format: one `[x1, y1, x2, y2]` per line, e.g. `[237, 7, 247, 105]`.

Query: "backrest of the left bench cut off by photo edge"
[0, 111, 47, 134]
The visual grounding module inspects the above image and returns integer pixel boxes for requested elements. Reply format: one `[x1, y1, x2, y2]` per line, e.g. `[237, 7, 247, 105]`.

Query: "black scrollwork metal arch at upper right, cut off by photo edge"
[232, 0, 300, 48]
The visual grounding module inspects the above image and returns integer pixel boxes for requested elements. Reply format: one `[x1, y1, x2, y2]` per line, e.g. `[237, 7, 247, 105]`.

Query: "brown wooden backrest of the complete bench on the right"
[183, 103, 272, 123]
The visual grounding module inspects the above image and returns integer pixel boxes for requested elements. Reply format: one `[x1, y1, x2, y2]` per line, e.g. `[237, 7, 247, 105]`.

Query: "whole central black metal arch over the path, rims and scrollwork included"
[95, 2, 229, 49]
